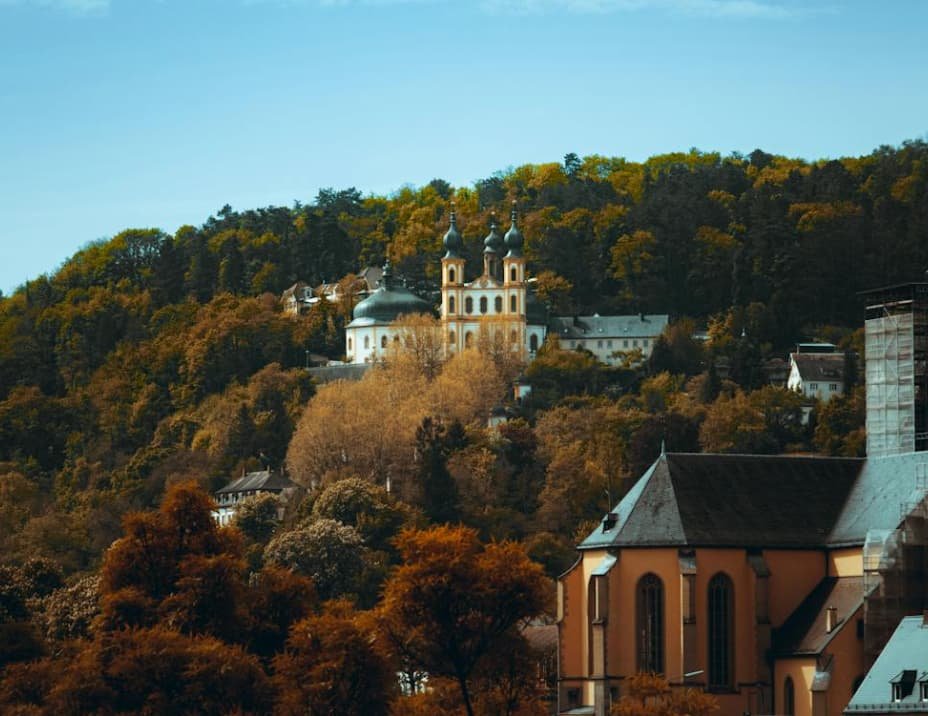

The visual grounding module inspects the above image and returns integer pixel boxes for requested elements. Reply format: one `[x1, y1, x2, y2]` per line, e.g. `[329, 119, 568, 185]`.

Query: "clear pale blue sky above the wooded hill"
[0, 0, 928, 295]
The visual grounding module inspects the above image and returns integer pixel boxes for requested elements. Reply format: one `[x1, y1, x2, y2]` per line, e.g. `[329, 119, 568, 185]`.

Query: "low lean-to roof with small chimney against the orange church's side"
[773, 577, 864, 656]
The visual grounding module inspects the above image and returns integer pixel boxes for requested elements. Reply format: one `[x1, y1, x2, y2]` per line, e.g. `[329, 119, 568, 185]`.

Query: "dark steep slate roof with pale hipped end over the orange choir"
[579, 453, 864, 549]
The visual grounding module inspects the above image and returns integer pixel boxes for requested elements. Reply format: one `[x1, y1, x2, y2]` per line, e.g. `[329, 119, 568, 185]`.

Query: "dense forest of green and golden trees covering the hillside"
[0, 141, 928, 713]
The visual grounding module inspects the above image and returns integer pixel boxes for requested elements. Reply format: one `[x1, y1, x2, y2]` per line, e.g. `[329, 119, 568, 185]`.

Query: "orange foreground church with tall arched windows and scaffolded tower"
[558, 283, 928, 716]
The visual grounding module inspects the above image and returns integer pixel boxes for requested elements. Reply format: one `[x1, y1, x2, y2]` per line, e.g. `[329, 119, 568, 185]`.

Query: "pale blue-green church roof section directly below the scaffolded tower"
[828, 452, 928, 546]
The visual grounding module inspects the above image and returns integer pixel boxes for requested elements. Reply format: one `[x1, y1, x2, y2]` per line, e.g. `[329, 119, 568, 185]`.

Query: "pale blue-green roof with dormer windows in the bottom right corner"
[844, 616, 928, 714]
